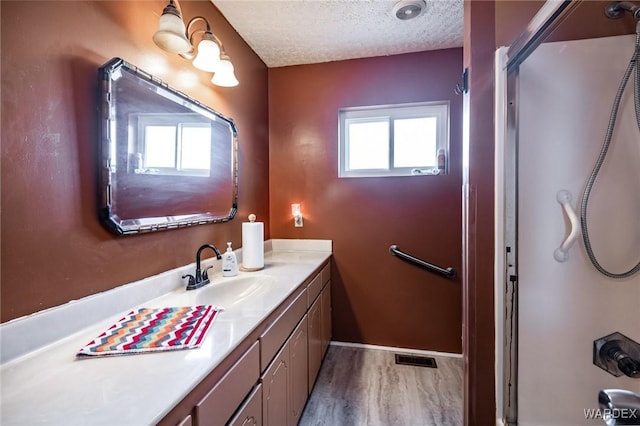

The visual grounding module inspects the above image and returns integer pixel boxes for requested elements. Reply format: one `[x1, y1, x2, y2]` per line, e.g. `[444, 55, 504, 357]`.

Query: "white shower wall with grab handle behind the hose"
[518, 35, 640, 426]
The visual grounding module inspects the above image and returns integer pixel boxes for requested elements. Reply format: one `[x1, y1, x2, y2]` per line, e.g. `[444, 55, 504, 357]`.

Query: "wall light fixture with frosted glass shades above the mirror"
[153, 0, 239, 87]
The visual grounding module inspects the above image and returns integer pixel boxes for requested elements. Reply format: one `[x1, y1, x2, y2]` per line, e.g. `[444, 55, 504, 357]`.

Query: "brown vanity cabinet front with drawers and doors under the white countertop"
[160, 246, 331, 426]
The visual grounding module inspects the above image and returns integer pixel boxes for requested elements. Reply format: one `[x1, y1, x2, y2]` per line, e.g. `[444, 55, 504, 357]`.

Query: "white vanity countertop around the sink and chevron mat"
[0, 240, 331, 426]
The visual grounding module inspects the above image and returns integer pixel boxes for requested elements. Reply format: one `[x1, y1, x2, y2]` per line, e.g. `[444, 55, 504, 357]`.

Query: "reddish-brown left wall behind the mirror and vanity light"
[0, 0, 269, 321]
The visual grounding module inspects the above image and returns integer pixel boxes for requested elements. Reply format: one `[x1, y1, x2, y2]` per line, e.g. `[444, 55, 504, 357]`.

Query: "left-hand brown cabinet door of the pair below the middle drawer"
[261, 341, 291, 426]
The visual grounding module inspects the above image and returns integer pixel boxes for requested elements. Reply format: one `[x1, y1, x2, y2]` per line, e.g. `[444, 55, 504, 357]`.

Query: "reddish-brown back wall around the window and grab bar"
[269, 49, 462, 353]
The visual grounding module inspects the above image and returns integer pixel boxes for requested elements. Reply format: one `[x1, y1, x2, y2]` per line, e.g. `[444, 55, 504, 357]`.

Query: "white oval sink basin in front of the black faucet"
[193, 274, 277, 309]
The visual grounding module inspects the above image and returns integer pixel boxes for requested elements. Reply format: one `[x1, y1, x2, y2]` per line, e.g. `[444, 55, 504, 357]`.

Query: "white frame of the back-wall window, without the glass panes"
[338, 101, 450, 178]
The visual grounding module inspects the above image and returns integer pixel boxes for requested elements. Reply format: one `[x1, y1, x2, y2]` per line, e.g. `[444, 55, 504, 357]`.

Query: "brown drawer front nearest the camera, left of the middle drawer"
[195, 342, 260, 426]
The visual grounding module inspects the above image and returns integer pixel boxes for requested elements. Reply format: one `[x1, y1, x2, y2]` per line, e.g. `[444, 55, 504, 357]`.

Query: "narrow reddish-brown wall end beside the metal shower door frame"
[463, 0, 499, 426]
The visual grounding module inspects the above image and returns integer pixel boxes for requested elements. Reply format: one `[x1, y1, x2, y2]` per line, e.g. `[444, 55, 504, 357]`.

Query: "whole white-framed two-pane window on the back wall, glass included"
[338, 101, 449, 177]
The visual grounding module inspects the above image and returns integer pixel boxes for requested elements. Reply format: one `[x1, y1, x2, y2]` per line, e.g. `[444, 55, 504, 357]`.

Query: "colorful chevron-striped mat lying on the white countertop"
[76, 305, 221, 357]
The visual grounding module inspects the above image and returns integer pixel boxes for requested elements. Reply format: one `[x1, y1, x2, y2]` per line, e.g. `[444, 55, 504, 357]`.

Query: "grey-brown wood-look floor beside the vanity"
[299, 345, 463, 426]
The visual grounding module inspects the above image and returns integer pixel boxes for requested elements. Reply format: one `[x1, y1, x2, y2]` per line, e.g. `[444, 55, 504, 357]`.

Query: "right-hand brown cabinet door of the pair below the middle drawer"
[289, 315, 309, 426]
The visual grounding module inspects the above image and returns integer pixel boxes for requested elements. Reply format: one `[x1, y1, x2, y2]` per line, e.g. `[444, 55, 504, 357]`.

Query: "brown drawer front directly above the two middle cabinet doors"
[259, 288, 307, 371]
